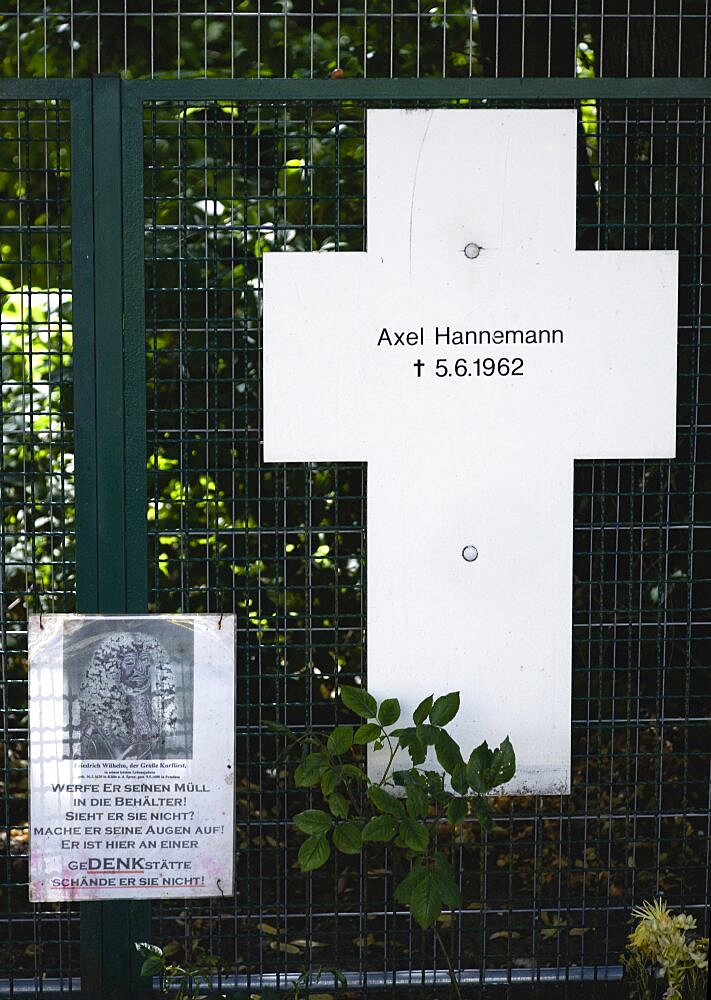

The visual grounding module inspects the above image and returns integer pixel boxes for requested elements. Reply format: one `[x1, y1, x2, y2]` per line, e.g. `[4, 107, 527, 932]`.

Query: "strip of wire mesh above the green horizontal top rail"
[0, 0, 709, 77]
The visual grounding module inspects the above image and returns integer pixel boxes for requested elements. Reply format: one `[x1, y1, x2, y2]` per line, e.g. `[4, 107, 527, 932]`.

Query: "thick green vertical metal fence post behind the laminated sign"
[72, 77, 150, 1000]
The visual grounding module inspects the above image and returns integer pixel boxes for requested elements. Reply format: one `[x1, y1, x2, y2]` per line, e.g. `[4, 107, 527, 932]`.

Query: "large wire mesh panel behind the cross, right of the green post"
[144, 94, 711, 989]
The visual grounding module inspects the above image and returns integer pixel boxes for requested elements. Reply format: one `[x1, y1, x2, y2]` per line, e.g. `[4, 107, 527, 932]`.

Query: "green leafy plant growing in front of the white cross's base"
[270, 685, 516, 996]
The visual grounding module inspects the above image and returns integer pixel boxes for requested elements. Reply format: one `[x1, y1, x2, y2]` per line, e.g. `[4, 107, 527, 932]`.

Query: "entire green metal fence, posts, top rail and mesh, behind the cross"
[0, 78, 711, 997]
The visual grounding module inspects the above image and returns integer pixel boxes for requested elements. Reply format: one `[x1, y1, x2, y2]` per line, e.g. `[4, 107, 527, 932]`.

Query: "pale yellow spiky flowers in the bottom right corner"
[622, 899, 709, 1000]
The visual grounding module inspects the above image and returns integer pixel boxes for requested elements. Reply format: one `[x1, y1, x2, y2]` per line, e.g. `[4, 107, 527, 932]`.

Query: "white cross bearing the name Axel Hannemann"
[264, 109, 677, 794]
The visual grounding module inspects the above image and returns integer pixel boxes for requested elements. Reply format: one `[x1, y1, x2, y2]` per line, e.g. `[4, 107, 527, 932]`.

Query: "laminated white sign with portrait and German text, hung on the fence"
[29, 615, 234, 902]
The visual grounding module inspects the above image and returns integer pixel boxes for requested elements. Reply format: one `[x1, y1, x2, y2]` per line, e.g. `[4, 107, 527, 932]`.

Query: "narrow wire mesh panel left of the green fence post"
[0, 101, 77, 980]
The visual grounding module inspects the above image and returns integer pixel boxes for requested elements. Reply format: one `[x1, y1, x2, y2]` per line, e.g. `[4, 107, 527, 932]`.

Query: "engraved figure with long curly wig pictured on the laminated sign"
[79, 632, 176, 760]
